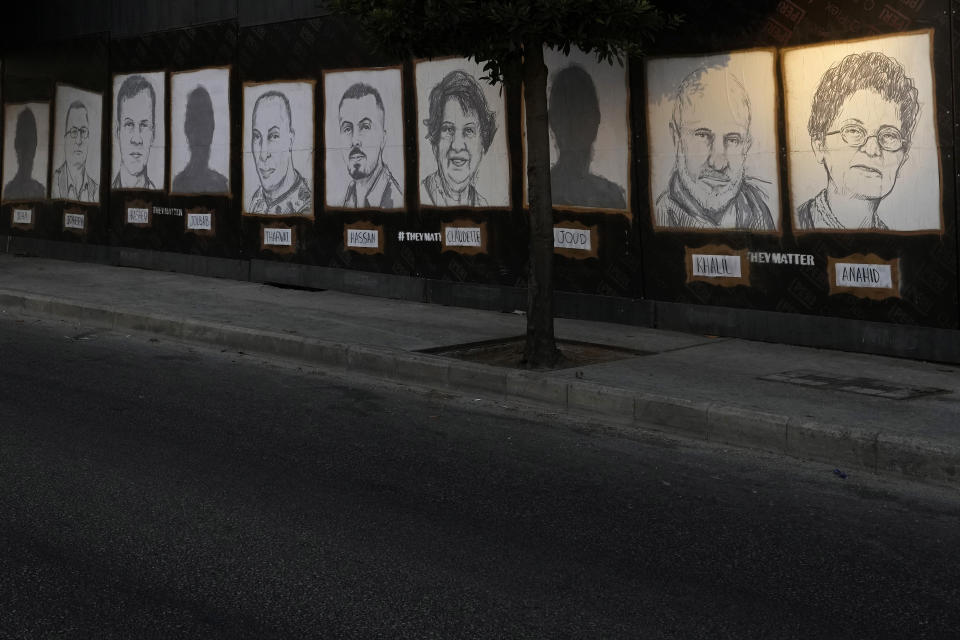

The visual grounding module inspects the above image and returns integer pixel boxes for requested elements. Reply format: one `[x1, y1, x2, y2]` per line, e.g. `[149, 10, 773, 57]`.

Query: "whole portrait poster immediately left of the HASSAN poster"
[243, 82, 314, 218]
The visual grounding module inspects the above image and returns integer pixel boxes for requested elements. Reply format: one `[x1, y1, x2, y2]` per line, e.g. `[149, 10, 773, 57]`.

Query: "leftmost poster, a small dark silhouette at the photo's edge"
[3, 102, 50, 202]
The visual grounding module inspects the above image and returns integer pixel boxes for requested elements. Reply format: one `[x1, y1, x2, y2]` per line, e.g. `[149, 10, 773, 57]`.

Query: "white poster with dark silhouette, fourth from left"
[170, 67, 230, 195]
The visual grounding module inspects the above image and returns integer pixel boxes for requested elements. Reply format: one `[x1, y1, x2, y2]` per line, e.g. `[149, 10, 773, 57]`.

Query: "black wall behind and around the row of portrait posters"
[0, 0, 960, 338]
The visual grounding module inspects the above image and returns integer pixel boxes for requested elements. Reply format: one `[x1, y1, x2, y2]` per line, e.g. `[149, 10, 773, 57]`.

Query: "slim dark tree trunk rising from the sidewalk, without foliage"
[523, 43, 560, 369]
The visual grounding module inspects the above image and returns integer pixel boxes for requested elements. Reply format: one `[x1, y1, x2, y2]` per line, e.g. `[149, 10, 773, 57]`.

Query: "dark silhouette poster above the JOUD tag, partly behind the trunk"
[523, 47, 630, 211]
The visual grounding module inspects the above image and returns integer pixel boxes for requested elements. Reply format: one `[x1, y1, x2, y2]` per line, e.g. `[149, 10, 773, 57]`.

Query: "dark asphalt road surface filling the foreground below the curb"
[0, 314, 960, 639]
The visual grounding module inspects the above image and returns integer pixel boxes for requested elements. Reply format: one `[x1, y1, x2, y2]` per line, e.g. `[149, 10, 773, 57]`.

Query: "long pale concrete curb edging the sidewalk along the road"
[0, 290, 960, 487]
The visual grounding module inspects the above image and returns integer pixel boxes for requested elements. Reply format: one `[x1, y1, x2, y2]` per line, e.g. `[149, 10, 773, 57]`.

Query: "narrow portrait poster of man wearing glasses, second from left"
[50, 85, 103, 203]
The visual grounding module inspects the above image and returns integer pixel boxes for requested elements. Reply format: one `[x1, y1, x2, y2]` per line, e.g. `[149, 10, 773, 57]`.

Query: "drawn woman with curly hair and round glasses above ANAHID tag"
[797, 52, 920, 230]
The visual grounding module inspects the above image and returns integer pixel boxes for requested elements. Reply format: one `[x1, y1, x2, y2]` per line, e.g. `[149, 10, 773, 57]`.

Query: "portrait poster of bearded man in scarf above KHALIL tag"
[646, 49, 781, 233]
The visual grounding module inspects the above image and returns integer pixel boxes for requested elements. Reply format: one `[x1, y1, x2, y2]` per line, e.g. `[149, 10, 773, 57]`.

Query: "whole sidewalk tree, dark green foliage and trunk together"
[331, 0, 678, 368]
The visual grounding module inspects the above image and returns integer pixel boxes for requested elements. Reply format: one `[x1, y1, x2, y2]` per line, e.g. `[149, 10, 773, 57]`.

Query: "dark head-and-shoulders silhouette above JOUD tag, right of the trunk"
[547, 64, 627, 209]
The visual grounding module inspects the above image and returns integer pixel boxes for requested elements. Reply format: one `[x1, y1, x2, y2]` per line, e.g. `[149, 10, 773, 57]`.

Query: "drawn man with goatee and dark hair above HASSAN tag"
[338, 82, 403, 209]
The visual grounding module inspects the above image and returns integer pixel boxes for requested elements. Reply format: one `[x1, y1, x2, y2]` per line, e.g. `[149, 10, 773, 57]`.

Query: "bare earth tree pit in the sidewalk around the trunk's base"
[421, 336, 651, 369]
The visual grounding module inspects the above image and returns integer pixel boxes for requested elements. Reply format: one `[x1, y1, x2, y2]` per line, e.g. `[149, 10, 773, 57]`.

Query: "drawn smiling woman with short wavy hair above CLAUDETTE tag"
[420, 69, 497, 207]
